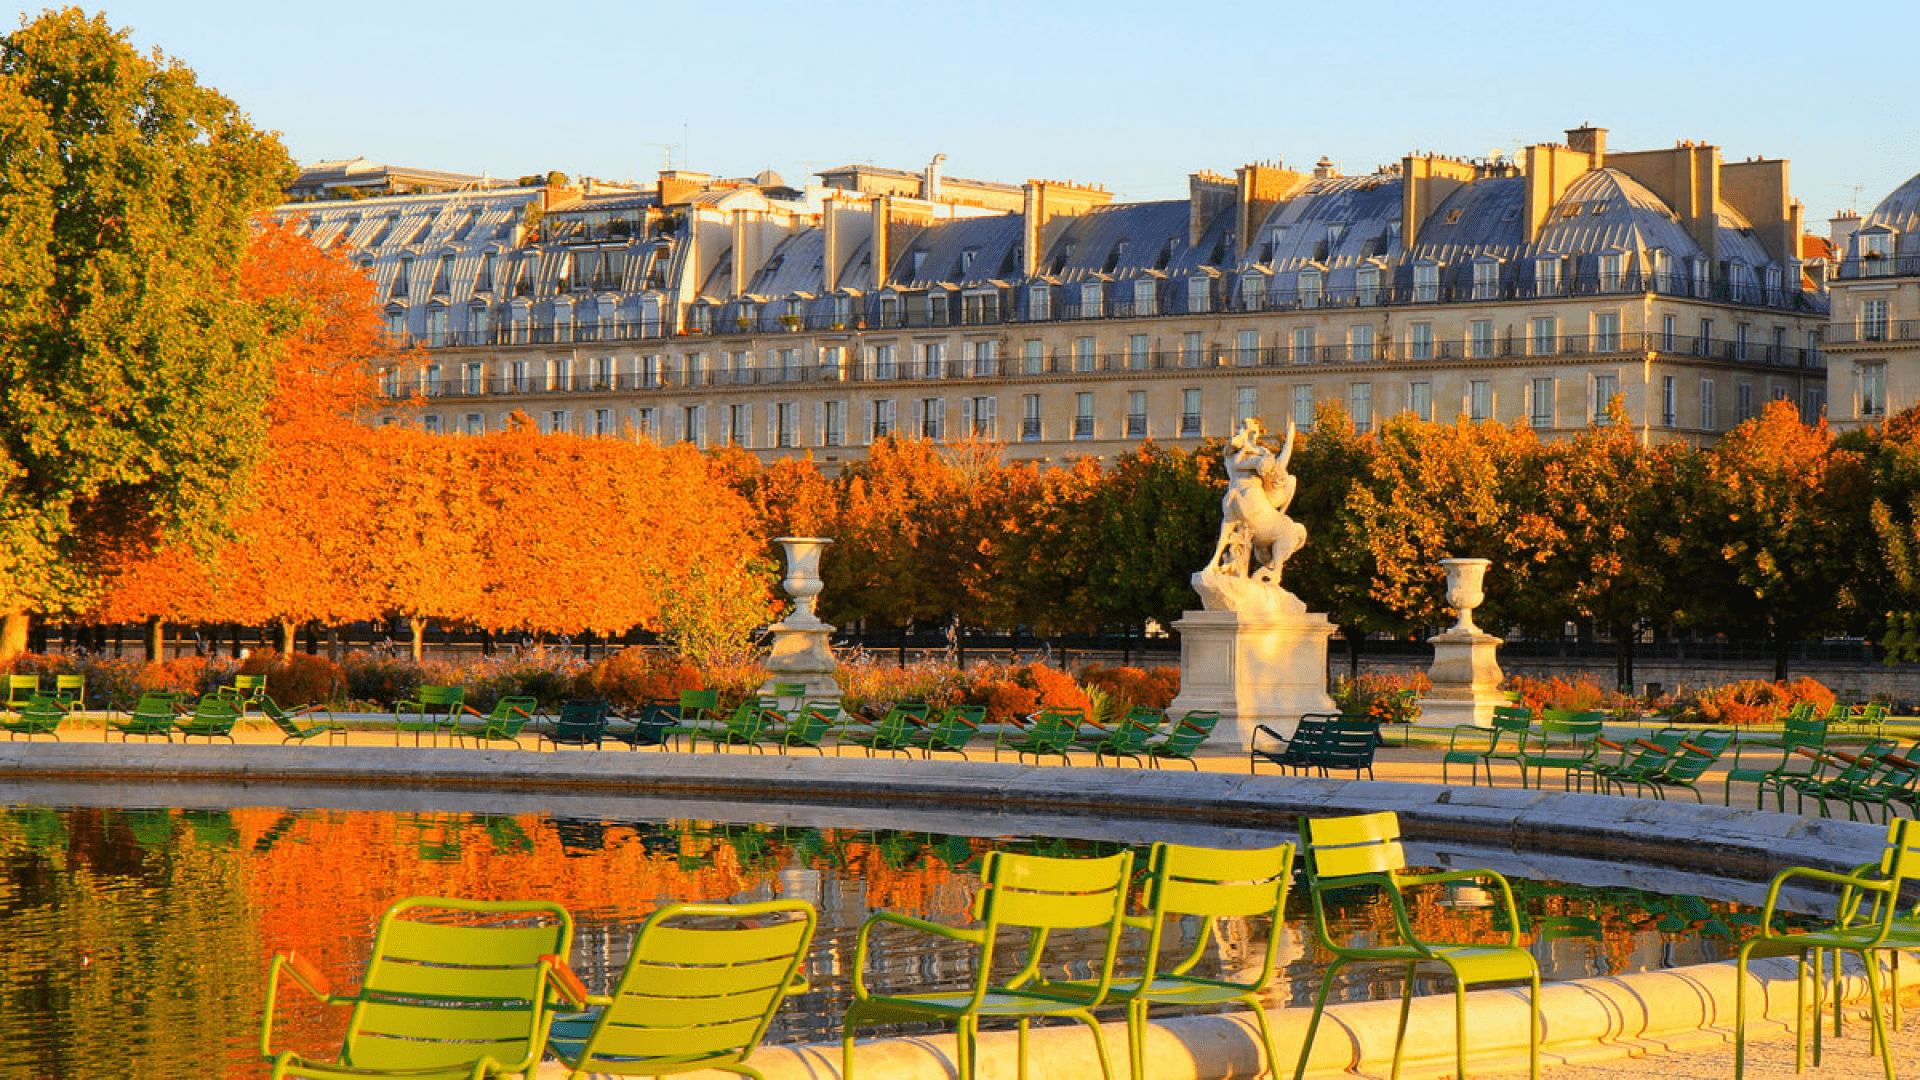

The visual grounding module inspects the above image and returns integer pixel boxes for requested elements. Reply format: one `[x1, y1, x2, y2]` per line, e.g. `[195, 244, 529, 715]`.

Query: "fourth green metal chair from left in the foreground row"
[1073, 842, 1294, 1076]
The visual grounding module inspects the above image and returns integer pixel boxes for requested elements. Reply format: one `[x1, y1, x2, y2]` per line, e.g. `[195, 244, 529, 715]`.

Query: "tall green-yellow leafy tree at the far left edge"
[0, 8, 292, 659]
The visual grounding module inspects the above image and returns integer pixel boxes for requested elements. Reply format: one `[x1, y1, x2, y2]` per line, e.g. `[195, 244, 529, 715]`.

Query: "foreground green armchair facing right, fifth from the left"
[1294, 811, 1540, 1080]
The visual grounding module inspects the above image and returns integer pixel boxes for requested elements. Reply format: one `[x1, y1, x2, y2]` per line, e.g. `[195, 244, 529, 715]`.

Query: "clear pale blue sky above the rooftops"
[41, 0, 1920, 233]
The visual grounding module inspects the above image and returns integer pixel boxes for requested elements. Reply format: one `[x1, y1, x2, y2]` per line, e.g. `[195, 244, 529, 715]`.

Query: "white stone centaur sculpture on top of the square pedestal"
[1192, 417, 1308, 615]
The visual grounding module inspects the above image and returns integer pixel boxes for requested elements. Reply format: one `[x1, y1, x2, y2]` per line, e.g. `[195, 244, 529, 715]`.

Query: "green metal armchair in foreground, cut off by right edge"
[1734, 819, 1920, 1080]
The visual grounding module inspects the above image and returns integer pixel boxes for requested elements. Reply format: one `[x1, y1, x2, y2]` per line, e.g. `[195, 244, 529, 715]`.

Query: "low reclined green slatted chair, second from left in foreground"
[547, 899, 818, 1080]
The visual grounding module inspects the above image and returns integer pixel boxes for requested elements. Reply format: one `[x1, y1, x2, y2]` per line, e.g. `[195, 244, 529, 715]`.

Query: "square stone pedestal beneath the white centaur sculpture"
[1167, 611, 1338, 749]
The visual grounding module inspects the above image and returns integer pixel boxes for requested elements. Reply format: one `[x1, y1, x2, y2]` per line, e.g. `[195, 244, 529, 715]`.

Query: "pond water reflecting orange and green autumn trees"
[0, 807, 1804, 1080]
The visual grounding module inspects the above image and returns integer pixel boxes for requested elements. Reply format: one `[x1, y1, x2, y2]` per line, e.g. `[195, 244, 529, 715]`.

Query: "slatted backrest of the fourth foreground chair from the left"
[1142, 842, 1294, 988]
